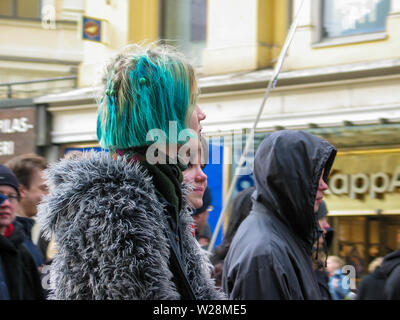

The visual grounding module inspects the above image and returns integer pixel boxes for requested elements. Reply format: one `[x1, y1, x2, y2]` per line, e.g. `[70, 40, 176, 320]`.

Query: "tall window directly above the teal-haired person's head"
[160, 0, 207, 66]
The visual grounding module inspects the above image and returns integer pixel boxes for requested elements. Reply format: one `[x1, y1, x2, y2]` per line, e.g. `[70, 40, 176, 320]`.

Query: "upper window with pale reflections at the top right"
[322, 0, 390, 38]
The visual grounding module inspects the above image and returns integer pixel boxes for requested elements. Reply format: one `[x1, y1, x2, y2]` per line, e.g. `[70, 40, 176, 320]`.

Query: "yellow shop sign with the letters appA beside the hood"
[325, 148, 400, 215]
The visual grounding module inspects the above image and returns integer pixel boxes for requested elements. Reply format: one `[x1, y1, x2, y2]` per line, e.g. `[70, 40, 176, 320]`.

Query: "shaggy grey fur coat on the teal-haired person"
[38, 152, 224, 300]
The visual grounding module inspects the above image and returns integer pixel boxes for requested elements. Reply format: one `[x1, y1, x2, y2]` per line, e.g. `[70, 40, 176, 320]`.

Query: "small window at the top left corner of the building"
[0, 0, 41, 19]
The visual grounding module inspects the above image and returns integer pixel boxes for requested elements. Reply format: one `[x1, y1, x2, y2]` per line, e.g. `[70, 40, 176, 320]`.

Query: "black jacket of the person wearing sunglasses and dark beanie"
[0, 222, 44, 300]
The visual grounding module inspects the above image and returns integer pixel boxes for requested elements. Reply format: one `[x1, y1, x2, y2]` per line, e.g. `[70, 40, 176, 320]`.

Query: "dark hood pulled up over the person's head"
[254, 130, 336, 249]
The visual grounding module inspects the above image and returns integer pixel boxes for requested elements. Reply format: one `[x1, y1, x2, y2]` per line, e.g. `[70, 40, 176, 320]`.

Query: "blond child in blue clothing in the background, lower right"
[326, 256, 351, 300]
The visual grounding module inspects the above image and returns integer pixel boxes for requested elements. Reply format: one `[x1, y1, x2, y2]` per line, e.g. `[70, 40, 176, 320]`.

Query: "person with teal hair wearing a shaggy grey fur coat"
[39, 46, 224, 299]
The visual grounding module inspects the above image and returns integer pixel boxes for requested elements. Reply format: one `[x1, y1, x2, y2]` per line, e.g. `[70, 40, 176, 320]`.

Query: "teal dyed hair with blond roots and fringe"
[97, 46, 197, 151]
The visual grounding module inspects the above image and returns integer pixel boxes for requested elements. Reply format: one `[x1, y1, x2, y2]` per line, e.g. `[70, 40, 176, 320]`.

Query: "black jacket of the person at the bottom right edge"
[381, 250, 400, 300]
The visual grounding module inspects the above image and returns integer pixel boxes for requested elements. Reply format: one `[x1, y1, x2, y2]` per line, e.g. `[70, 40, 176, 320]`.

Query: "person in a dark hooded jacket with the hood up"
[222, 130, 336, 300]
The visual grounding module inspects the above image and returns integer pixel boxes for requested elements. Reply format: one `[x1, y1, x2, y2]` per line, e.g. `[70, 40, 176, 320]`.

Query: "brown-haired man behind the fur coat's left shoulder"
[5, 153, 47, 267]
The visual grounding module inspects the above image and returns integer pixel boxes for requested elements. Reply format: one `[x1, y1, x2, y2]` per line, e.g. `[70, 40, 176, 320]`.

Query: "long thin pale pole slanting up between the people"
[208, 0, 305, 253]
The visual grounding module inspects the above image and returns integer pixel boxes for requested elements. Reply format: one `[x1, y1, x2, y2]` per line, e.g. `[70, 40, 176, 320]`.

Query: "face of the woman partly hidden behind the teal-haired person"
[182, 143, 207, 209]
